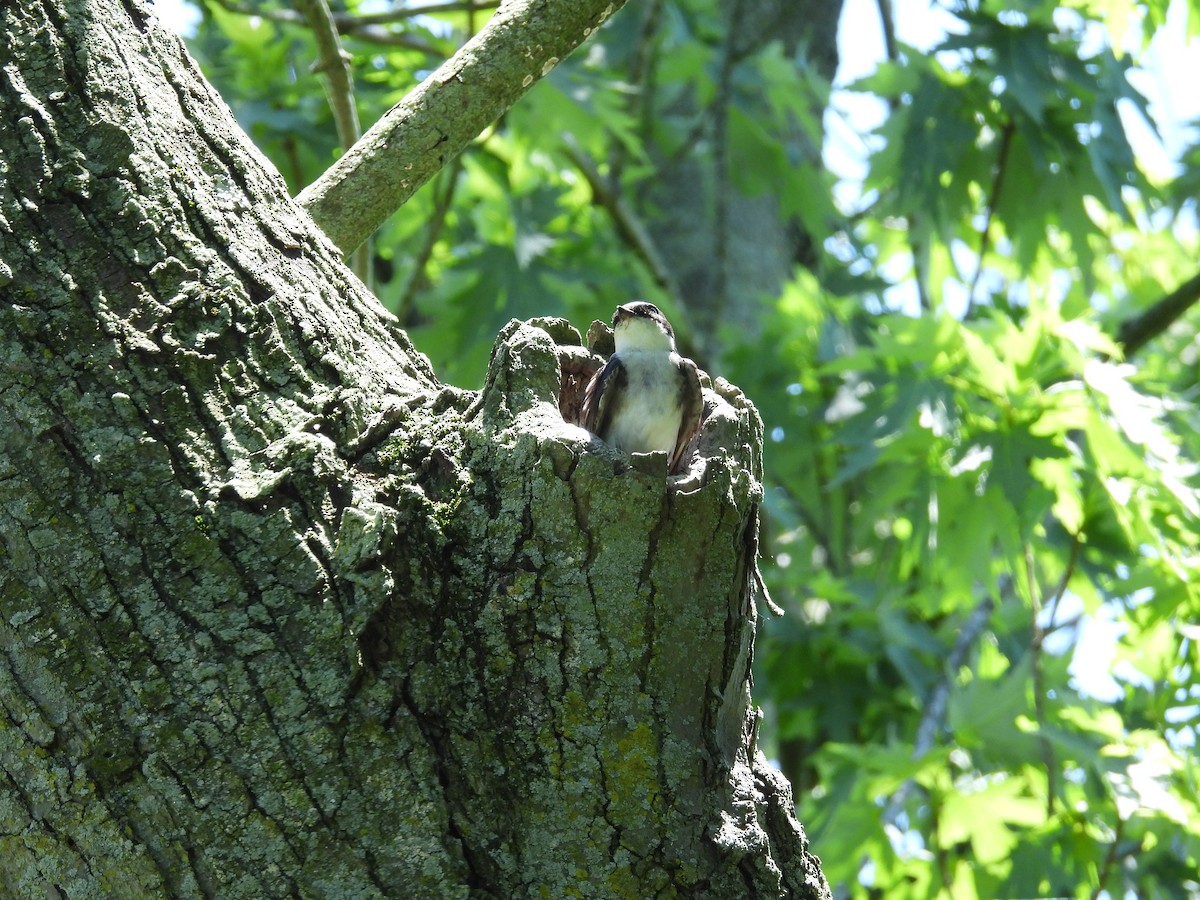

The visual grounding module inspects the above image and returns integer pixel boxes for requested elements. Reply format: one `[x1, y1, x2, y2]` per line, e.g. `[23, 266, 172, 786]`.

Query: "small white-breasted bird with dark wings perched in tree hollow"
[580, 300, 703, 474]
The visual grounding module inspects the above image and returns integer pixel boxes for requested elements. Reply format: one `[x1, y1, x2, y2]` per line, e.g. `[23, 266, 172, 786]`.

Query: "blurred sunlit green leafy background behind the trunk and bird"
[164, 0, 1200, 899]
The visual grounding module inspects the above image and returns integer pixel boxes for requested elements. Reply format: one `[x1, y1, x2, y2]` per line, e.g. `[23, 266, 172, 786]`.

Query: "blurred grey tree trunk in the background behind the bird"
[625, 0, 842, 359]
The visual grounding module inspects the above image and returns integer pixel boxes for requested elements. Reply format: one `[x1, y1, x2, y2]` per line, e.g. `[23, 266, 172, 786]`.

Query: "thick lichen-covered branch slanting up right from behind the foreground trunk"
[296, 0, 624, 251]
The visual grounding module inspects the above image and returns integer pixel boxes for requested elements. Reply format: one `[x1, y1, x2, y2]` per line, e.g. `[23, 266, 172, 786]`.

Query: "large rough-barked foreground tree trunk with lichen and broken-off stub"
[0, 0, 828, 898]
